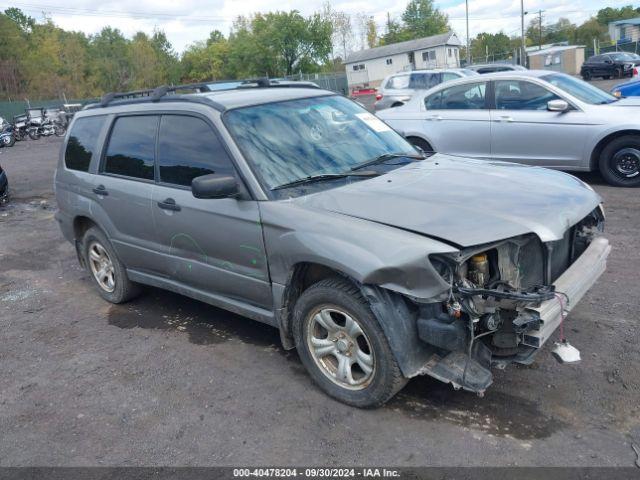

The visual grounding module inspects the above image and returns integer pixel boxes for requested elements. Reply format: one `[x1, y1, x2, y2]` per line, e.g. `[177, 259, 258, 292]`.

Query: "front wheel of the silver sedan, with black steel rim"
[598, 135, 640, 187]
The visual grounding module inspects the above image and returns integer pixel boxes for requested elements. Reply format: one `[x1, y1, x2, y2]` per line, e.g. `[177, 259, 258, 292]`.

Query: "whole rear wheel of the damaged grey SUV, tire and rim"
[82, 227, 140, 303]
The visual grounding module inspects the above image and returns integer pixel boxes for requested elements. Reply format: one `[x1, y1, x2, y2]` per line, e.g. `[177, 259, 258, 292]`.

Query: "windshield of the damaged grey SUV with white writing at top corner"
[225, 95, 416, 190]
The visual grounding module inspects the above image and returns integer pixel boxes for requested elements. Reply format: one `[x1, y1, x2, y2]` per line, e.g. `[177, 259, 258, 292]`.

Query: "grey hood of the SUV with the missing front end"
[293, 154, 600, 247]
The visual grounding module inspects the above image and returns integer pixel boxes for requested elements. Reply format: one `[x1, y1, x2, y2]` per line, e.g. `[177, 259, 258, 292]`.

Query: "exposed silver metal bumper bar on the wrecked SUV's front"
[522, 237, 611, 348]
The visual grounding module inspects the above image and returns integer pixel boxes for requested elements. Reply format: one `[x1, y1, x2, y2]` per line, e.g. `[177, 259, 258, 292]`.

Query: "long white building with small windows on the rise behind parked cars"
[344, 32, 460, 87]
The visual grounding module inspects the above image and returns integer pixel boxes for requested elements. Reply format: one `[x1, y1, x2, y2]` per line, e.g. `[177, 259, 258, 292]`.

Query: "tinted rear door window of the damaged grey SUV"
[104, 115, 158, 180]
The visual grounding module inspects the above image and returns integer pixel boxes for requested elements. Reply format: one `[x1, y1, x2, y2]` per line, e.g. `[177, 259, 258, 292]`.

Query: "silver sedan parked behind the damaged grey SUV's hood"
[378, 70, 640, 187]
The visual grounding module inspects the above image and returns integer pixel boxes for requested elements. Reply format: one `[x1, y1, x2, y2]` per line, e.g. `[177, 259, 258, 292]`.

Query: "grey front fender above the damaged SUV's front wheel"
[260, 201, 458, 300]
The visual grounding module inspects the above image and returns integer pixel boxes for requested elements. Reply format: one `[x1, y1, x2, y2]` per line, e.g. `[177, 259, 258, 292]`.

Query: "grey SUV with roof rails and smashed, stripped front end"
[55, 81, 610, 407]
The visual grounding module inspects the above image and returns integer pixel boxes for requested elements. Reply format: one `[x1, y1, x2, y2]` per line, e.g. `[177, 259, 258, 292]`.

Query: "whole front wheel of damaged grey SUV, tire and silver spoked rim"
[293, 277, 407, 408]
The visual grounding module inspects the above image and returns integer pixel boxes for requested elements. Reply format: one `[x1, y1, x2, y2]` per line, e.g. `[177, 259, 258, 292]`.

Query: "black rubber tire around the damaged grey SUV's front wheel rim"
[293, 277, 407, 408]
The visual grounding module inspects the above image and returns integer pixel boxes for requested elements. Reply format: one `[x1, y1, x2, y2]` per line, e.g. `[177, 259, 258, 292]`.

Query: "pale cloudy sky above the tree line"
[0, 0, 632, 52]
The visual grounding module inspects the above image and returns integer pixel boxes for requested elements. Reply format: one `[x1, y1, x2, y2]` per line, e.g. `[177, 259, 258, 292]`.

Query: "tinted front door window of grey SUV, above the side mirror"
[158, 115, 234, 186]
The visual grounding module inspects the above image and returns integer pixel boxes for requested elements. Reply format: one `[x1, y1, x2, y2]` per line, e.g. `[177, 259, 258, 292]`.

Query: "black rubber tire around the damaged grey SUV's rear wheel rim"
[82, 227, 140, 303]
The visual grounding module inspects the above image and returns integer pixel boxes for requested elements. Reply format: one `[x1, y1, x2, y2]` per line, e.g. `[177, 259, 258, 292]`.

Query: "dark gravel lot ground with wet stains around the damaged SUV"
[0, 133, 640, 466]
